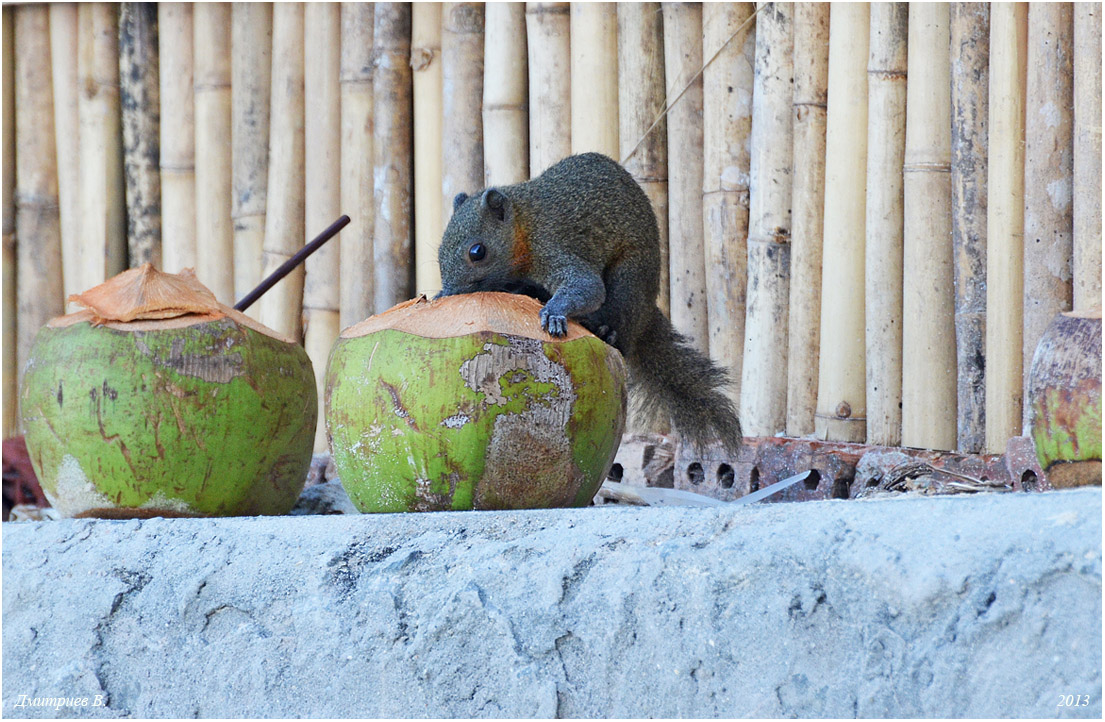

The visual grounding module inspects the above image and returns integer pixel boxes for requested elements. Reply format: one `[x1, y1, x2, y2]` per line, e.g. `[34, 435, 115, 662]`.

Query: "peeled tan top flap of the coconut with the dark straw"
[46, 263, 295, 344]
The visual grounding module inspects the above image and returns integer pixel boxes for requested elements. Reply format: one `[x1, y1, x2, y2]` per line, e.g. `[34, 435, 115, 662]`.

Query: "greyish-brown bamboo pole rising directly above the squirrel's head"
[439, 2, 484, 281]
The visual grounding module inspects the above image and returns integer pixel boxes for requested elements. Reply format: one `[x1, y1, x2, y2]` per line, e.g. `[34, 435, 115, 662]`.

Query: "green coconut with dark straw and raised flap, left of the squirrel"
[20, 264, 318, 517]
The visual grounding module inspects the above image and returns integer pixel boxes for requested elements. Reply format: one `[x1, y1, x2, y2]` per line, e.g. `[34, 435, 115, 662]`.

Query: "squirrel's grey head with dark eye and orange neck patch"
[438, 188, 528, 296]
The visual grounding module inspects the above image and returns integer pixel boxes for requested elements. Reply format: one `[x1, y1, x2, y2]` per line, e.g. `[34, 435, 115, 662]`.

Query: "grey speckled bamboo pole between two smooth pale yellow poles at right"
[950, 2, 990, 453]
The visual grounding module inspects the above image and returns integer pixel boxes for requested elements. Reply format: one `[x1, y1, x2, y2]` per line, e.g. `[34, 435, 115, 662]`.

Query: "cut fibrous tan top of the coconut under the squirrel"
[341, 292, 591, 342]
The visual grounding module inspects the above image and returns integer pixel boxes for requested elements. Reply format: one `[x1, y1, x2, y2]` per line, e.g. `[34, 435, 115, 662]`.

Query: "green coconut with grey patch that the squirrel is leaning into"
[325, 293, 627, 512]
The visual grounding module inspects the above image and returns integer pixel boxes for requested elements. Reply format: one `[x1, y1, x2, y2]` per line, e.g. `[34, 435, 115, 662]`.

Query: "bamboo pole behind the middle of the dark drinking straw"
[257, 2, 304, 338]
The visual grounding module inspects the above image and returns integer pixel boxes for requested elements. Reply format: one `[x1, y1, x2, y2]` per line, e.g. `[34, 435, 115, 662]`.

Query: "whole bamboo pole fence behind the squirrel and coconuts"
[3, 2, 1101, 453]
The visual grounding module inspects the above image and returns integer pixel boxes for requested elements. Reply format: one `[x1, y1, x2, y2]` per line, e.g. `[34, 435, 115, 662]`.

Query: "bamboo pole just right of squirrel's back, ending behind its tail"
[661, 2, 707, 353]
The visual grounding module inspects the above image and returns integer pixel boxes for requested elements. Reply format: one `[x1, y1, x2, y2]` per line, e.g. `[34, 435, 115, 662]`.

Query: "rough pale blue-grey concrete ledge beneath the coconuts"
[2, 489, 1102, 718]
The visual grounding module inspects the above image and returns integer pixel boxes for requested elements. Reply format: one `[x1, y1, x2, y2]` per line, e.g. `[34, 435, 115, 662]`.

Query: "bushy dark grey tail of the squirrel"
[627, 308, 741, 452]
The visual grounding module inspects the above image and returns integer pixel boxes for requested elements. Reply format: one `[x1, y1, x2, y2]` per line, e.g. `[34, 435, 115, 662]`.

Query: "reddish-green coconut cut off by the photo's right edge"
[1028, 306, 1102, 488]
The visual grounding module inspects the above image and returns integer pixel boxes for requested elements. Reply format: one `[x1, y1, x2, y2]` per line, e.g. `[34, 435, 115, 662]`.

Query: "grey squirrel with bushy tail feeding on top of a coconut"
[438, 153, 741, 451]
